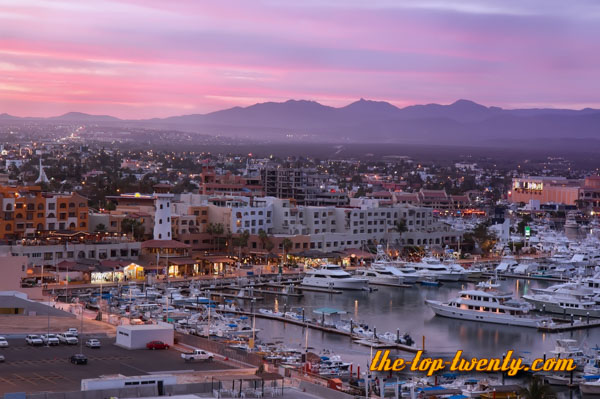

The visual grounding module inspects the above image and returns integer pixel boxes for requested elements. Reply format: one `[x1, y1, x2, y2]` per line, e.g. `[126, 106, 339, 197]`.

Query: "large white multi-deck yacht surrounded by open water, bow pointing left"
[425, 290, 551, 327]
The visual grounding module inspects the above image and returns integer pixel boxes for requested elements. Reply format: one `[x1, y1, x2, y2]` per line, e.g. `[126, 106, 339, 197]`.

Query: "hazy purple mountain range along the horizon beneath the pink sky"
[0, 99, 600, 146]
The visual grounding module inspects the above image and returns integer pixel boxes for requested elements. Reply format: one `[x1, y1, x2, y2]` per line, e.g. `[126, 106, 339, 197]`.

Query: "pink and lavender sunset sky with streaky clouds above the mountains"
[0, 0, 600, 119]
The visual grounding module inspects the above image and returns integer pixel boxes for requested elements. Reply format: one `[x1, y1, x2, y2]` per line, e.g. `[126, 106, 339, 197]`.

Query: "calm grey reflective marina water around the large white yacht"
[251, 279, 600, 367]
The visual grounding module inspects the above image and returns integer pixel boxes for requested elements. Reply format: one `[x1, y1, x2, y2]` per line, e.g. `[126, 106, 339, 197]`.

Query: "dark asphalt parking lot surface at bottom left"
[0, 337, 233, 394]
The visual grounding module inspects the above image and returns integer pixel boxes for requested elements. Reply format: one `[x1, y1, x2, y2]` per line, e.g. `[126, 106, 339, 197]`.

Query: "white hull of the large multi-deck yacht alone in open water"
[425, 300, 541, 328]
